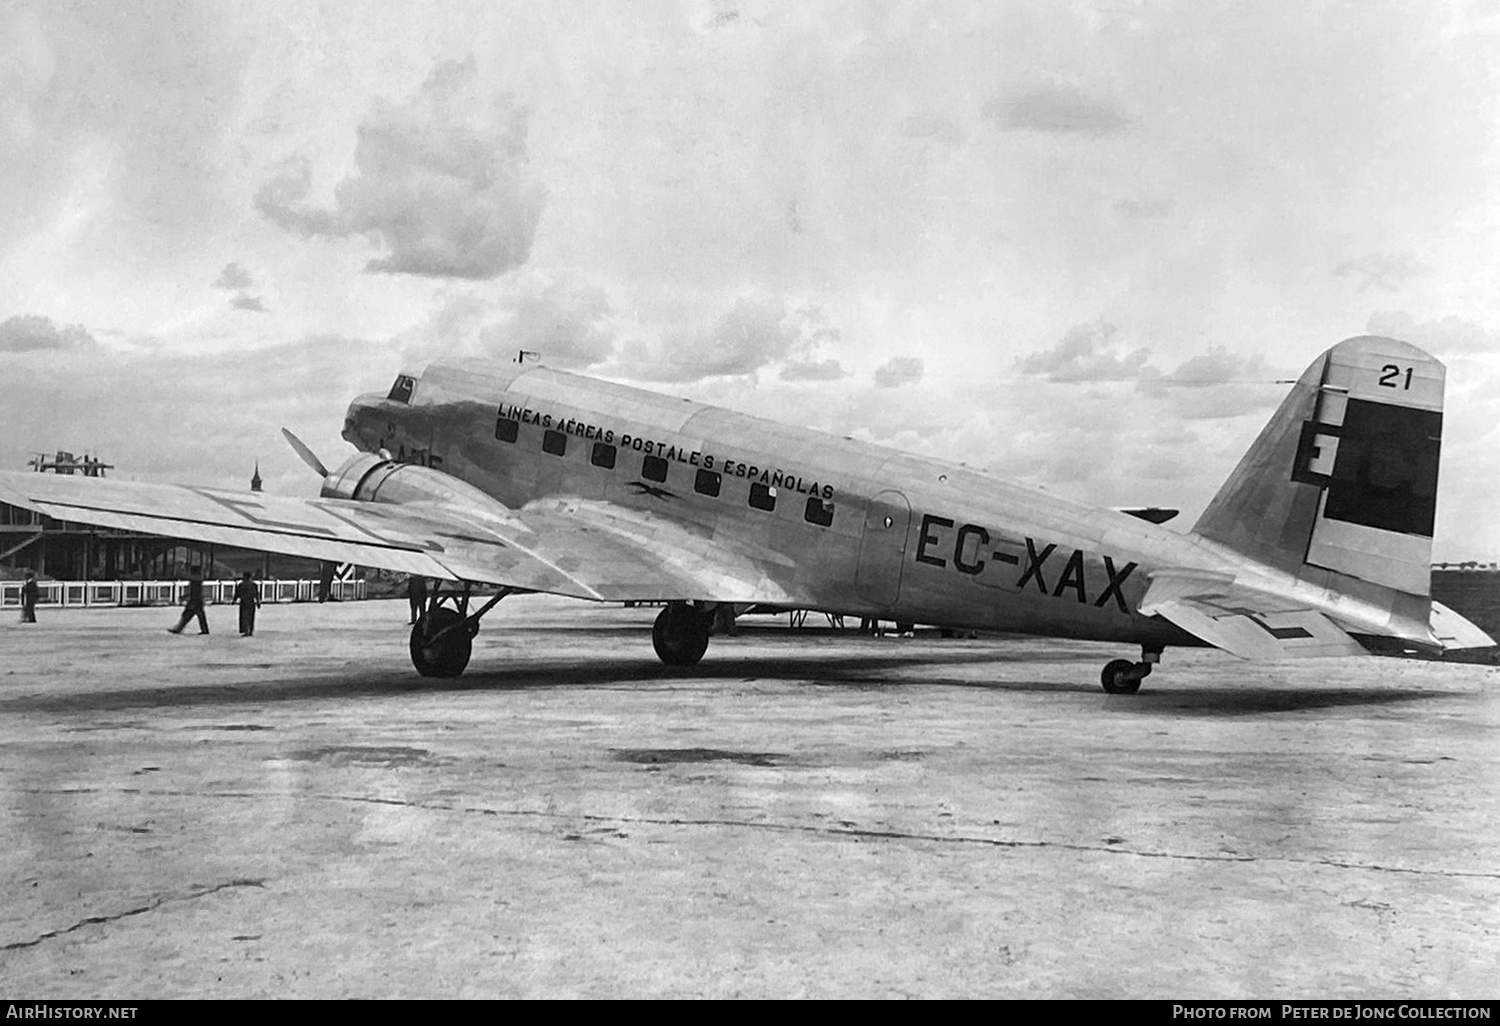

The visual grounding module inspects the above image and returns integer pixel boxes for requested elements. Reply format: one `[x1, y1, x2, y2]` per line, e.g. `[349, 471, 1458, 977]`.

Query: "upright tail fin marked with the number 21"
[1193, 336, 1445, 597]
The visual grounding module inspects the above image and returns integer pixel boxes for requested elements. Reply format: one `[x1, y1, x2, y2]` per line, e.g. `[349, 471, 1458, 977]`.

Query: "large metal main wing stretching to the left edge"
[0, 473, 791, 602]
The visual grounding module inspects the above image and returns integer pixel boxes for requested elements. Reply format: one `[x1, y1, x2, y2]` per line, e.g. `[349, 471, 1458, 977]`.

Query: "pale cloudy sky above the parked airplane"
[0, 0, 1500, 560]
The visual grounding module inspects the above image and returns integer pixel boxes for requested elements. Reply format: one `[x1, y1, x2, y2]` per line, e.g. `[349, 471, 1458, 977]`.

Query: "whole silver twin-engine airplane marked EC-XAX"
[0, 336, 1494, 695]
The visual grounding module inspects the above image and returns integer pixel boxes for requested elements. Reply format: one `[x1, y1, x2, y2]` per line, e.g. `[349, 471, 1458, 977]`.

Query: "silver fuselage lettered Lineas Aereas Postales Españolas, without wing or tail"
[344, 363, 1223, 647]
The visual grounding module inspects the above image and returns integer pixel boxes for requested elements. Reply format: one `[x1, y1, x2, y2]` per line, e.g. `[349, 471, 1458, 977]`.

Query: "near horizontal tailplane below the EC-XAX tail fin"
[1140, 570, 1370, 660]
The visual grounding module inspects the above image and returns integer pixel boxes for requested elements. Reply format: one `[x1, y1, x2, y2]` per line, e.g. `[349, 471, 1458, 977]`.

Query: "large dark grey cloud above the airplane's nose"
[255, 57, 546, 279]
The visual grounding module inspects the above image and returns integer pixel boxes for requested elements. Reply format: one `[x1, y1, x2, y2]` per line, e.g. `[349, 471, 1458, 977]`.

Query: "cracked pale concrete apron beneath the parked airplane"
[0, 597, 1500, 998]
